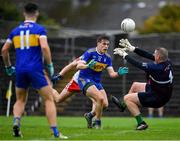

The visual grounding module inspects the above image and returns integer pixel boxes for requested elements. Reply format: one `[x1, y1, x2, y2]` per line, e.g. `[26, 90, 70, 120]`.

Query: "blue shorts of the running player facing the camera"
[78, 77, 104, 94]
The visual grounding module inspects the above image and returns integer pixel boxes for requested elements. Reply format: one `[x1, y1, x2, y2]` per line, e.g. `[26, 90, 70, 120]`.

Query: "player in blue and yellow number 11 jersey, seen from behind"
[2, 3, 67, 138]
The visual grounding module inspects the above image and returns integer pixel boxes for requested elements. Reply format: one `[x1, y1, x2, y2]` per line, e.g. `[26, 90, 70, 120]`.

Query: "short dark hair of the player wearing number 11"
[24, 3, 39, 14]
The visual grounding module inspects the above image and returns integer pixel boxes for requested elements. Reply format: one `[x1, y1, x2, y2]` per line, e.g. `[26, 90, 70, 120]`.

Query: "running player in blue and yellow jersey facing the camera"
[77, 35, 128, 129]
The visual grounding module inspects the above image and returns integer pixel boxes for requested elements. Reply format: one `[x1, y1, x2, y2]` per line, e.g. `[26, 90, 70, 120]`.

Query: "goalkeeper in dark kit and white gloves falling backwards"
[112, 39, 173, 130]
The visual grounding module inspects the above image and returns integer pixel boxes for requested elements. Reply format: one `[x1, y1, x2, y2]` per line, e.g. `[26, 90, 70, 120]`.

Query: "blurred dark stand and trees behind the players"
[0, 0, 180, 116]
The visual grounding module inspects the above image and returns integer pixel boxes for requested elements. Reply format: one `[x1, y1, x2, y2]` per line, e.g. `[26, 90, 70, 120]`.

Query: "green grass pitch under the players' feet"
[0, 116, 180, 140]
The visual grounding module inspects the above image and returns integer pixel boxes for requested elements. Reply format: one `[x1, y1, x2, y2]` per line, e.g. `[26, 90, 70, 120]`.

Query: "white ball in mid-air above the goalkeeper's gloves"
[121, 18, 136, 33]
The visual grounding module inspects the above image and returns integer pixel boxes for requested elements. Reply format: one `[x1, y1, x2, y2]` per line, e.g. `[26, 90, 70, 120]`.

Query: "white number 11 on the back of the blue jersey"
[20, 30, 29, 50]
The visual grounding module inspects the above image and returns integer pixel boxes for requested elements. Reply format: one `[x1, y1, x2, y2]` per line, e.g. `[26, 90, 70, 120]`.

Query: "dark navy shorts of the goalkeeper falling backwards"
[138, 84, 170, 108]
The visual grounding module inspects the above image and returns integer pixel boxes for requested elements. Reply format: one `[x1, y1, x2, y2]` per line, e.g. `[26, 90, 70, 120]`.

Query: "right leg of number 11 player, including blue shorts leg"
[32, 70, 67, 138]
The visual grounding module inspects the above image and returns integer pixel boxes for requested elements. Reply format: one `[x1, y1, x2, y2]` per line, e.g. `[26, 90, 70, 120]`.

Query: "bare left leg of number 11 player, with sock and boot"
[13, 87, 28, 137]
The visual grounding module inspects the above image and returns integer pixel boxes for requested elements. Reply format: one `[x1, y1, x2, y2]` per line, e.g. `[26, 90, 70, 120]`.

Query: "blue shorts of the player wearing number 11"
[16, 70, 48, 89]
